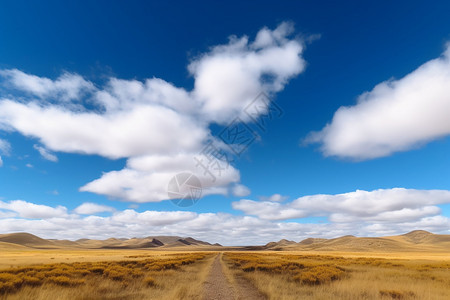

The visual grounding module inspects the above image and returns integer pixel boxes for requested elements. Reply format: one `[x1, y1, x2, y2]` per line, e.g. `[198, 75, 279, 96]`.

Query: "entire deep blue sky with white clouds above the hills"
[0, 1, 450, 244]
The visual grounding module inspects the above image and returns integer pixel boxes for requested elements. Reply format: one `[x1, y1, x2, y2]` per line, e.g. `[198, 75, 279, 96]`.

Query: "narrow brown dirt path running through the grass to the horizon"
[203, 254, 266, 300]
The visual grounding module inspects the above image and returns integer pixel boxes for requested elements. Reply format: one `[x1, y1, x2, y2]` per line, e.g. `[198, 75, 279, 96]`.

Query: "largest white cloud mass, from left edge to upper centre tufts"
[0, 23, 305, 202]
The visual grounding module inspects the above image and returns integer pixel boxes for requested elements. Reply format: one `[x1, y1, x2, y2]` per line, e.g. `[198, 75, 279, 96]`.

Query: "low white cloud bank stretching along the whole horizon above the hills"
[0, 196, 450, 245]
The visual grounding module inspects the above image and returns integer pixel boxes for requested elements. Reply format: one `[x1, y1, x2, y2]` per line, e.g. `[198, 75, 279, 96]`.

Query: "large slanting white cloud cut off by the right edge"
[307, 44, 450, 160]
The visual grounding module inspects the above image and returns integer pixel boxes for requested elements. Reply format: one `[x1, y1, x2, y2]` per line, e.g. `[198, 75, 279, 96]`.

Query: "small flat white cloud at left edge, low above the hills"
[0, 200, 67, 219]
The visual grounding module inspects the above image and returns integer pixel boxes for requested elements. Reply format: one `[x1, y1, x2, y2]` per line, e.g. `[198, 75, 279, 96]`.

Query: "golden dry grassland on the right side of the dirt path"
[223, 252, 450, 299]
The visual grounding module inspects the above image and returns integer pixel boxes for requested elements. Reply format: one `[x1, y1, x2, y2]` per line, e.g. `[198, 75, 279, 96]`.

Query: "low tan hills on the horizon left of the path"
[0, 233, 221, 249]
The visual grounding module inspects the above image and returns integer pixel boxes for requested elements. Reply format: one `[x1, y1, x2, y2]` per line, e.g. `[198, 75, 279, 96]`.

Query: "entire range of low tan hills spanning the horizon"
[0, 230, 450, 252]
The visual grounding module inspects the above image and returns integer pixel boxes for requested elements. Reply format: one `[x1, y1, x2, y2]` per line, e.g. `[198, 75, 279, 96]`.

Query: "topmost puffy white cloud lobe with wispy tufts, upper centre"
[189, 23, 305, 123]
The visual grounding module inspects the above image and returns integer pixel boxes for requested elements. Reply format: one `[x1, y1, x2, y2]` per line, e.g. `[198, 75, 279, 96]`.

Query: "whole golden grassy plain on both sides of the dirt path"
[0, 249, 450, 300]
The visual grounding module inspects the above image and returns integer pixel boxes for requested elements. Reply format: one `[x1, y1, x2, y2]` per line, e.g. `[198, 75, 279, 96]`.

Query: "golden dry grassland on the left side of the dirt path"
[0, 253, 213, 299]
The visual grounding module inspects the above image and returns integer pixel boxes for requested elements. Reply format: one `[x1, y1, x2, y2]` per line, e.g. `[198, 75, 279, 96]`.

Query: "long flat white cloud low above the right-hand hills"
[232, 188, 450, 223]
